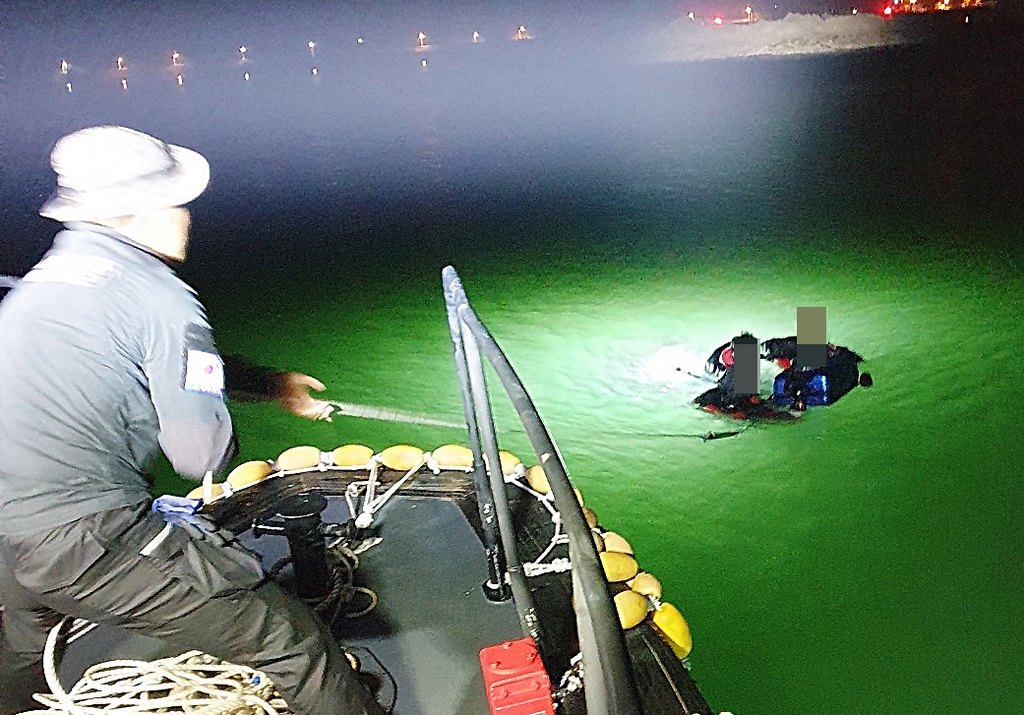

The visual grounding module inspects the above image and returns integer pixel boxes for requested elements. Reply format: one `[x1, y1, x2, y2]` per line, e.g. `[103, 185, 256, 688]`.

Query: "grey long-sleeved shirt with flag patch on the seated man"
[0, 223, 234, 535]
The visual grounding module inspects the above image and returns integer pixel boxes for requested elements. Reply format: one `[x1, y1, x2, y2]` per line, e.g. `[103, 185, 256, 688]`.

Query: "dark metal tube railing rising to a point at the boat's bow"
[441, 266, 641, 715]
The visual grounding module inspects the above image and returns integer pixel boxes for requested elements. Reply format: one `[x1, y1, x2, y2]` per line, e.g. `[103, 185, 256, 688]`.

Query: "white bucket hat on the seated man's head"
[39, 126, 210, 222]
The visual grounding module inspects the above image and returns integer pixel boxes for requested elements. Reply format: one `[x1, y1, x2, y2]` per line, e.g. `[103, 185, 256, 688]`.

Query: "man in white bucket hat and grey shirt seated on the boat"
[0, 127, 382, 715]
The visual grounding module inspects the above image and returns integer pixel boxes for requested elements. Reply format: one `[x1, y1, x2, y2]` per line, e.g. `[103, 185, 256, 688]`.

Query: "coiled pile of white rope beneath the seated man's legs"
[23, 619, 290, 715]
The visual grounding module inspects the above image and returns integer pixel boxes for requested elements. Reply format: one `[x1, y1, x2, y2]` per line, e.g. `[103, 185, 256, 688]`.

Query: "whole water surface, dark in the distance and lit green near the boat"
[0, 5, 1024, 715]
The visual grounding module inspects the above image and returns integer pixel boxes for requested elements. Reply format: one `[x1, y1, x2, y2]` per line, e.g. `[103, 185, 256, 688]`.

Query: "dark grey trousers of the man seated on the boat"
[0, 503, 382, 715]
